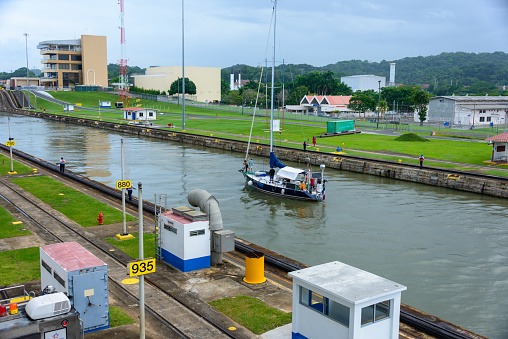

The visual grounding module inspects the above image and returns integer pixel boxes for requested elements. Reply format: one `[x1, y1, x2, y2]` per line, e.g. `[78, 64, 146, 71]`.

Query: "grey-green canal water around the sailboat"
[0, 113, 508, 338]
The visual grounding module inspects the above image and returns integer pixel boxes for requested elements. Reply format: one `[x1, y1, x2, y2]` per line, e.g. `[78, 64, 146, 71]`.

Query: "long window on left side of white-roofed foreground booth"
[300, 286, 349, 327]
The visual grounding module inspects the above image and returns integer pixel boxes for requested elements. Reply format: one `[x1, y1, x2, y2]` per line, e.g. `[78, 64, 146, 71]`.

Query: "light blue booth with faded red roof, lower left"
[40, 242, 109, 333]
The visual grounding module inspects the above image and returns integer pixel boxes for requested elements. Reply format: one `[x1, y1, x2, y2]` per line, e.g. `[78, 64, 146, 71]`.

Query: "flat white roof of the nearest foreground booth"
[289, 261, 407, 304]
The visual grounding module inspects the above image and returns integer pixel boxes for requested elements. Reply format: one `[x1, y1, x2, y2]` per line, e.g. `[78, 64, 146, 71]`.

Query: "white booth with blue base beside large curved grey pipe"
[158, 206, 211, 272]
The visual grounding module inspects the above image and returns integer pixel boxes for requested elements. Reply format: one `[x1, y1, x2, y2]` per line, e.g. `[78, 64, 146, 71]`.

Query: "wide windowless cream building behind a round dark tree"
[132, 66, 221, 102]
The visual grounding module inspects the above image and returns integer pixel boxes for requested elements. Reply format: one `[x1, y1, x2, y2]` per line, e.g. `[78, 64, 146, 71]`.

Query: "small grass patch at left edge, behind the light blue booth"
[0, 247, 41, 285]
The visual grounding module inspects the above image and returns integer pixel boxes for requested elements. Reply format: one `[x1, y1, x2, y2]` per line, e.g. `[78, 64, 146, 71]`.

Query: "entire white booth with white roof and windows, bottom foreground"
[289, 261, 407, 339]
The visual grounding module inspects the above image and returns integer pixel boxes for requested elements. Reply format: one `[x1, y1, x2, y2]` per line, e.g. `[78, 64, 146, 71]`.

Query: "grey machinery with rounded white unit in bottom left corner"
[0, 285, 83, 339]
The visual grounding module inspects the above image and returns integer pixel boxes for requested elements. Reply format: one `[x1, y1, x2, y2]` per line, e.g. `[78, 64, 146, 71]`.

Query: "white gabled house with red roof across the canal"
[286, 95, 353, 115]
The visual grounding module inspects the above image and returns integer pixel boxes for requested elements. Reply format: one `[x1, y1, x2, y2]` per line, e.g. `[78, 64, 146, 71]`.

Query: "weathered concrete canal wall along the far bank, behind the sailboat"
[7, 110, 508, 198]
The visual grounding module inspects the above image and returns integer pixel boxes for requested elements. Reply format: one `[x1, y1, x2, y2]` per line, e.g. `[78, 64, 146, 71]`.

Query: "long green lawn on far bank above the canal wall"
[24, 91, 503, 173]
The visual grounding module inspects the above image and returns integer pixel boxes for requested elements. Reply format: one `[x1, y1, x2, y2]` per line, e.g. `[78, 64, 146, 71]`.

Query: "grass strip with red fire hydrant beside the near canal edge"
[11, 177, 137, 227]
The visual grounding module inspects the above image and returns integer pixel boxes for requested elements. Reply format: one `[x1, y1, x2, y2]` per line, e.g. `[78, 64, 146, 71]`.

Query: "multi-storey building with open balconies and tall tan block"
[37, 35, 108, 88]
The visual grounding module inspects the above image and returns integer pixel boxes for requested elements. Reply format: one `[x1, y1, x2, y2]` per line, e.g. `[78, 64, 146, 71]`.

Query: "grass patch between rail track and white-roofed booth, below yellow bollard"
[210, 295, 292, 334]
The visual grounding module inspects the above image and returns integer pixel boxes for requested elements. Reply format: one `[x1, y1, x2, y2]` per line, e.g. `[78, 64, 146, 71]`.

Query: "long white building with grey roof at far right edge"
[427, 96, 508, 127]
